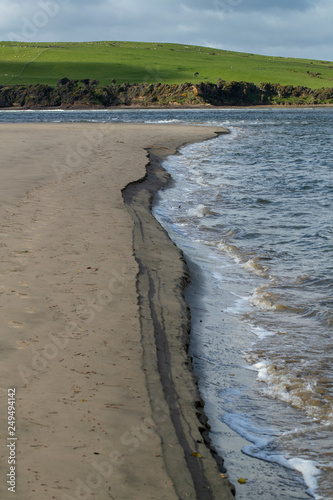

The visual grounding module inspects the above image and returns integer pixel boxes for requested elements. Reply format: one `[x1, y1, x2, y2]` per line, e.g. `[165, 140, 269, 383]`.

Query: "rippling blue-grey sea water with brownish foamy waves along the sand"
[0, 108, 333, 500]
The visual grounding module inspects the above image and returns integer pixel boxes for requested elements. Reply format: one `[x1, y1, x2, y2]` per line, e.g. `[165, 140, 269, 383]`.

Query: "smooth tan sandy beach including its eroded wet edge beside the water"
[0, 124, 234, 500]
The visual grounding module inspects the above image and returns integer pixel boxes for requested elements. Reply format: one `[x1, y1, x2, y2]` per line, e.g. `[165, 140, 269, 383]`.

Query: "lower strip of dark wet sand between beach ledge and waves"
[123, 133, 235, 500]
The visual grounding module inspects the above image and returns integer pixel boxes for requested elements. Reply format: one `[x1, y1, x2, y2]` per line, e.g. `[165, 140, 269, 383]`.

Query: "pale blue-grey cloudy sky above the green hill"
[0, 0, 333, 61]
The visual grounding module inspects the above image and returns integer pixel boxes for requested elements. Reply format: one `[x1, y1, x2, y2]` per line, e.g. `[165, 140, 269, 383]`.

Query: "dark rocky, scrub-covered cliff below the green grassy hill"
[0, 78, 333, 108]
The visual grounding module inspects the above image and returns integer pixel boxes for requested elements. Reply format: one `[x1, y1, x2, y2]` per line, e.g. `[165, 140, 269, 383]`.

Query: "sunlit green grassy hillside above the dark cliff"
[0, 42, 333, 89]
